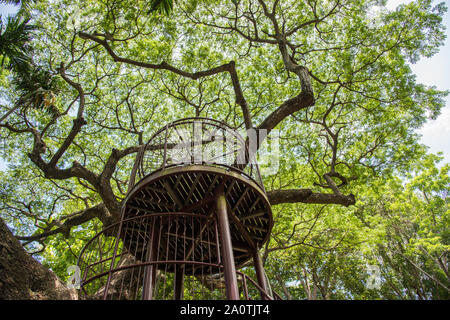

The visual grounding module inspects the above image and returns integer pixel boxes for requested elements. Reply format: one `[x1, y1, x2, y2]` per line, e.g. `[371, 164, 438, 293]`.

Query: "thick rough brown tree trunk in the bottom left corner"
[0, 219, 78, 300]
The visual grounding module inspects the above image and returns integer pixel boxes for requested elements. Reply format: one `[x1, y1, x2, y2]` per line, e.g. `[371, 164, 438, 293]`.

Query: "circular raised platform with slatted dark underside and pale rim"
[123, 165, 273, 268]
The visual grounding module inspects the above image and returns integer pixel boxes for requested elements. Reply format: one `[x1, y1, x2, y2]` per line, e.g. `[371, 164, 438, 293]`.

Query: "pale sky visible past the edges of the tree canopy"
[0, 0, 450, 170]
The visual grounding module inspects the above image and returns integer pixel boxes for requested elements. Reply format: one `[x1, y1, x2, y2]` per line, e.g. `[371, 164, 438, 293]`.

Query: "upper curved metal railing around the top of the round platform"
[128, 117, 264, 190]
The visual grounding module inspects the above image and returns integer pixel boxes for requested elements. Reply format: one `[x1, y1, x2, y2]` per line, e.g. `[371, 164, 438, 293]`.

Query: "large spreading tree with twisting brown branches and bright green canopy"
[0, 0, 446, 298]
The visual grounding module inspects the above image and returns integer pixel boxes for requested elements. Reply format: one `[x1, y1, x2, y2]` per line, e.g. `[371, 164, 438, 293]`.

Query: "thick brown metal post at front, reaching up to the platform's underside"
[216, 185, 239, 300]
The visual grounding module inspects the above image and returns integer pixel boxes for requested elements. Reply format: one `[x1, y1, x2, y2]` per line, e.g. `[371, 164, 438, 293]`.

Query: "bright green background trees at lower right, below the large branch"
[266, 155, 450, 299]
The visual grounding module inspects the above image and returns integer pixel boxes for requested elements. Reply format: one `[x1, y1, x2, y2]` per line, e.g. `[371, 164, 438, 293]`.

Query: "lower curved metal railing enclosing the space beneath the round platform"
[78, 212, 276, 300]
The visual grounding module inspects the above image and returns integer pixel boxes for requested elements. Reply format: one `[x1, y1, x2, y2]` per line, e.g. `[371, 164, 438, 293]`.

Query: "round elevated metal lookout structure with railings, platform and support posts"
[78, 118, 279, 300]
